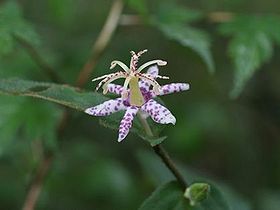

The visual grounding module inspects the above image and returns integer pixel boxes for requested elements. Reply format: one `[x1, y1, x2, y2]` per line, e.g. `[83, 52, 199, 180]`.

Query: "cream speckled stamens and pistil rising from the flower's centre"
[92, 50, 169, 106]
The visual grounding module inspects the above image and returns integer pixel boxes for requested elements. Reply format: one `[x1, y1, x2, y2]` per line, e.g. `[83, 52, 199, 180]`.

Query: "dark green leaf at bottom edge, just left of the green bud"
[139, 181, 189, 210]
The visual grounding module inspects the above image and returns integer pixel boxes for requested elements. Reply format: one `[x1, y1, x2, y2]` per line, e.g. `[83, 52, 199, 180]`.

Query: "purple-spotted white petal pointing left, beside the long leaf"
[85, 98, 126, 116]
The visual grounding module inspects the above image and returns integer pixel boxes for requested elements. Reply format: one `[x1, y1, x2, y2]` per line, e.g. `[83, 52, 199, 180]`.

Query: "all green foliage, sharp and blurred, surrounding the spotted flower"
[0, 0, 280, 210]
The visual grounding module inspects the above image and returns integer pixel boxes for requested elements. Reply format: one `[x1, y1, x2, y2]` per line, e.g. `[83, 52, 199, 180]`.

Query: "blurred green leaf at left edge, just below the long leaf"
[0, 96, 61, 153]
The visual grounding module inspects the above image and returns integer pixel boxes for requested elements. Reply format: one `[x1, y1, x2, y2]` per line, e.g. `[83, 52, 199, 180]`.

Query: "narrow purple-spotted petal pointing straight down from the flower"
[118, 106, 139, 142]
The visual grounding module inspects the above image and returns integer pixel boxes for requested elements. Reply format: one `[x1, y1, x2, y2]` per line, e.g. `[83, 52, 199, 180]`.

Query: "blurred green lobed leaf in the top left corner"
[0, 1, 39, 54]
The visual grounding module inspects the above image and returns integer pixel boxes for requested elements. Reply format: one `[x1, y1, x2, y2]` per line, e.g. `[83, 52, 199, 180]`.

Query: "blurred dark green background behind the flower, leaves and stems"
[0, 0, 280, 210]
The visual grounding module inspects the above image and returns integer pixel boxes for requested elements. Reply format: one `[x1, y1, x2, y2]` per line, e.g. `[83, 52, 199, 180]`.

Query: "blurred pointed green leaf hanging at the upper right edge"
[219, 16, 280, 98]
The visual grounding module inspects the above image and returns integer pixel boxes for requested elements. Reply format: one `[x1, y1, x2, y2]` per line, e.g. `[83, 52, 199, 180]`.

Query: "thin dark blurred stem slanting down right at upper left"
[14, 36, 62, 83]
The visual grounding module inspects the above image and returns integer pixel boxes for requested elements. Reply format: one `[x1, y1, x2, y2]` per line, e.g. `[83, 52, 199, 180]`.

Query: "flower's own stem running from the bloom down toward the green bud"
[138, 114, 188, 190]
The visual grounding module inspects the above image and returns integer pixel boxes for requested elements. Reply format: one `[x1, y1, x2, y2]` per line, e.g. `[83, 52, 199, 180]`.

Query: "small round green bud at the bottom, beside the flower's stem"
[184, 183, 210, 206]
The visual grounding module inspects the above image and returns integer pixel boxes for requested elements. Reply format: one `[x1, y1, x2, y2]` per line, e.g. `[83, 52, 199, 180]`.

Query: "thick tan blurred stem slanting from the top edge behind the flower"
[76, 0, 123, 87]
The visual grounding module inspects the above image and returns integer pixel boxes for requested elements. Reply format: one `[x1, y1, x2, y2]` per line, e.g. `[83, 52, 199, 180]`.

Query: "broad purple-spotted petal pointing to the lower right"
[141, 99, 176, 125]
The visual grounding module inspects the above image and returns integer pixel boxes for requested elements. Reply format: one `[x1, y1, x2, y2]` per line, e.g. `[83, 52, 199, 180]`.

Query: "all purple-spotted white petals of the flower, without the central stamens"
[85, 66, 189, 142]
